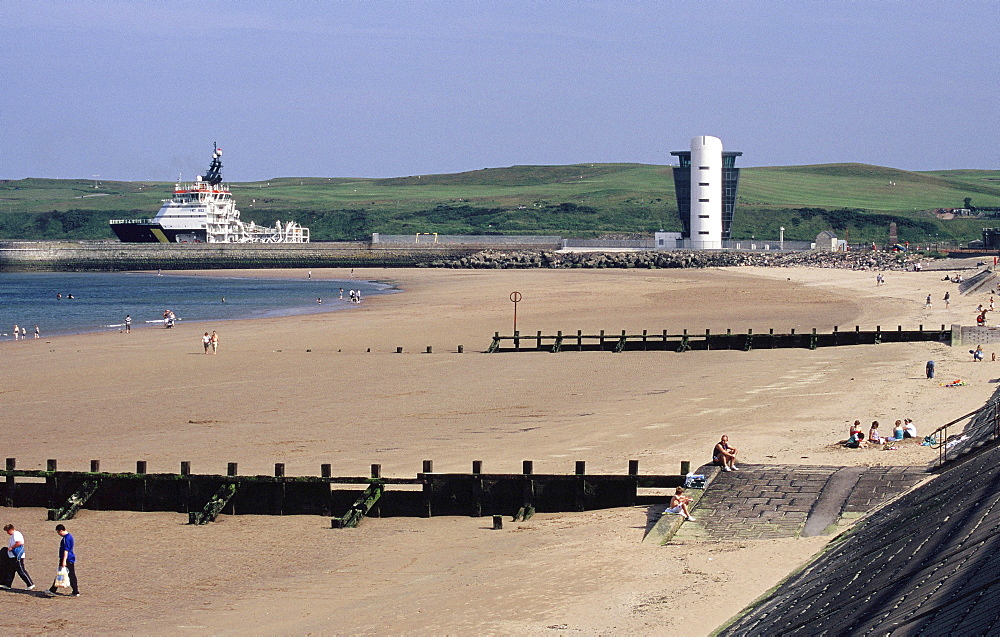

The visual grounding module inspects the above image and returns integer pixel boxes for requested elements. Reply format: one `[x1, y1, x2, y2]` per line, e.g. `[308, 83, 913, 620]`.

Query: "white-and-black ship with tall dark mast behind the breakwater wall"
[108, 144, 309, 243]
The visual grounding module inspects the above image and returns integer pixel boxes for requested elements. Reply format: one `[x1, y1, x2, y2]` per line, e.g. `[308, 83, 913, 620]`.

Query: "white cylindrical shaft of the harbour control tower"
[691, 135, 722, 250]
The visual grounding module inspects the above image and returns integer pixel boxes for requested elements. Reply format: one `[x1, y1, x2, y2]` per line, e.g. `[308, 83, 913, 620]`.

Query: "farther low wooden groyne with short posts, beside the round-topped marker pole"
[486, 325, 957, 354]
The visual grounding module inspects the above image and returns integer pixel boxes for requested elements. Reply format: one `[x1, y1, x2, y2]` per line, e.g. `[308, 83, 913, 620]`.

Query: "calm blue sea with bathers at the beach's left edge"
[0, 272, 397, 338]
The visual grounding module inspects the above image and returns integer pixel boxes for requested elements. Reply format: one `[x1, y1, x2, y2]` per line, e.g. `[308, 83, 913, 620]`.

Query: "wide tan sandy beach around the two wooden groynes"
[0, 268, 1000, 635]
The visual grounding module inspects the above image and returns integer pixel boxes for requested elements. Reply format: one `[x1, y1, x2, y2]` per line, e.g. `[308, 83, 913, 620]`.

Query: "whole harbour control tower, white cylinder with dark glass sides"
[670, 135, 743, 250]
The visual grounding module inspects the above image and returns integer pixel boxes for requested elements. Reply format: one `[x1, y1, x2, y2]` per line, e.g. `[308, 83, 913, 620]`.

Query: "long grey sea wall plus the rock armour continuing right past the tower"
[0, 241, 910, 272]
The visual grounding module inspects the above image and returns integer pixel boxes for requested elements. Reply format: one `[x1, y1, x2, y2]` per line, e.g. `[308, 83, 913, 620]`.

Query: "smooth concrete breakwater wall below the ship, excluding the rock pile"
[0, 241, 548, 272]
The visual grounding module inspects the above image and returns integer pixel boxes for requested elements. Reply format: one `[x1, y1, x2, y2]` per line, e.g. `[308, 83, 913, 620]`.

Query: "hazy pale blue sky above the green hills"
[0, 0, 1000, 182]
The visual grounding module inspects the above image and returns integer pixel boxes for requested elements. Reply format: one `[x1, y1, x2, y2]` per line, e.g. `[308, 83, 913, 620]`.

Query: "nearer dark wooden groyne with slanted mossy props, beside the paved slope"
[0, 458, 690, 528]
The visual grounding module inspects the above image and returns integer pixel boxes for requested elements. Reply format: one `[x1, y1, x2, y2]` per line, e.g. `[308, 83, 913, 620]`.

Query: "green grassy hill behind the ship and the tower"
[0, 164, 1000, 242]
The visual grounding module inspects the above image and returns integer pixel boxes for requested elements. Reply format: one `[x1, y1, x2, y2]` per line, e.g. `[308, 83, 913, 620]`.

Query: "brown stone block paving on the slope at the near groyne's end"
[674, 465, 927, 540]
